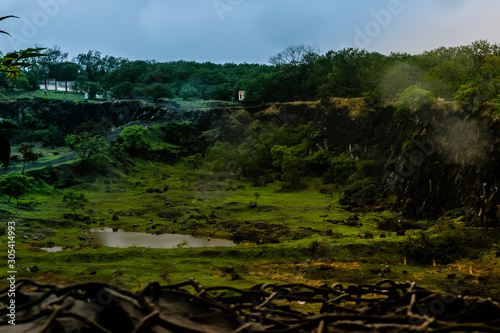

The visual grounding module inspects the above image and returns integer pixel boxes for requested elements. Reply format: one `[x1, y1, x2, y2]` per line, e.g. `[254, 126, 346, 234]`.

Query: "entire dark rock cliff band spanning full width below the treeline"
[0, 99, 500, 220]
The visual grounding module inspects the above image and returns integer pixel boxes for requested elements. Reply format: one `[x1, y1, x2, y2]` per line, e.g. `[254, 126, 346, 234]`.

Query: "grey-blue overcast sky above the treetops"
[0, 0, 500, 63]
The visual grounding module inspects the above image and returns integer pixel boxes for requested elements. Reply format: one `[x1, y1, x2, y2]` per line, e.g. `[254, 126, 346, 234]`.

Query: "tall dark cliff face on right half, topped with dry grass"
[250, 99, 500, 221]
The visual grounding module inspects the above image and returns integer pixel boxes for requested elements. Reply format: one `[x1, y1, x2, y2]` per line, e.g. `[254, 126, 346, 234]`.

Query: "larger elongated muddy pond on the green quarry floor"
[90, 228, 236, 249]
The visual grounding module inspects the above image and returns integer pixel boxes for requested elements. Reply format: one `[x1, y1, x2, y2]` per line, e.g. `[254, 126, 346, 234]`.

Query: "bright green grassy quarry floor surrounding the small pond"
[0, 156, 500, 297]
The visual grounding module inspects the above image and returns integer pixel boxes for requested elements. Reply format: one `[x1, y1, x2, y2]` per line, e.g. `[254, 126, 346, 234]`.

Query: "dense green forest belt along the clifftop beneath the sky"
[0, 40, 500, 108]
